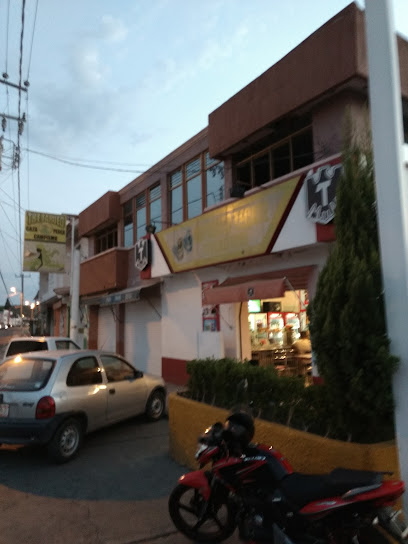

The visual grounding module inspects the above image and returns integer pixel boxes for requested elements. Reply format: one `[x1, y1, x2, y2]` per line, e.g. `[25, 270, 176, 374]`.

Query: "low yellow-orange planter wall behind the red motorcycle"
[169, 393, 400, 479]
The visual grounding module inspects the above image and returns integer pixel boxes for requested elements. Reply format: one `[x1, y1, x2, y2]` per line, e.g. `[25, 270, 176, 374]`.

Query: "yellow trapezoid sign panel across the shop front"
[156, 176, 303, 272]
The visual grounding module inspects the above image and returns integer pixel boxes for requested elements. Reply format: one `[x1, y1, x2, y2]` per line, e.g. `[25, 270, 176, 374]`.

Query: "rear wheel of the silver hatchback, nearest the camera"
[48, 418, 84, 463]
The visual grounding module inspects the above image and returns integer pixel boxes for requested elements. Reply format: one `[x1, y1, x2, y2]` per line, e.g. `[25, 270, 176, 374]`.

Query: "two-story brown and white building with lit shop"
[75, 4, 408, 383]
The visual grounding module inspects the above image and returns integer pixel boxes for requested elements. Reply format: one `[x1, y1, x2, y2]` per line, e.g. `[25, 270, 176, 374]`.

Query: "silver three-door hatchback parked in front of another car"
[0, 350, 166, 463]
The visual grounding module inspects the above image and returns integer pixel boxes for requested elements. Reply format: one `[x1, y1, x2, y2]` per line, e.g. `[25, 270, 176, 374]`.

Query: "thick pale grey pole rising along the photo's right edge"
[365, 0, 408, 517]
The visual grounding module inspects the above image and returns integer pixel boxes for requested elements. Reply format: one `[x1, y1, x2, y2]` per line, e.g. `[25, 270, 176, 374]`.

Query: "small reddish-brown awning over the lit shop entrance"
[203, 278, 285, 305]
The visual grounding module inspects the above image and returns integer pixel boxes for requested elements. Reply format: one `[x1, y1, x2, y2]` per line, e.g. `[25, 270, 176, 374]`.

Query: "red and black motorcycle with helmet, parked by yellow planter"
[169, 412, 408, 544]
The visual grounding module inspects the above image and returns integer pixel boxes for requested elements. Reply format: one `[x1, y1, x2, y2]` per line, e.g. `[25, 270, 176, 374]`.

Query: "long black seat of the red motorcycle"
[280, 468, 383, 509]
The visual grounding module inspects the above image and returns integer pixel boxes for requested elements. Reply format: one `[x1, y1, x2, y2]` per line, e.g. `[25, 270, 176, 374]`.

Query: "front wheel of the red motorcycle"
[169, 484, 236, 543]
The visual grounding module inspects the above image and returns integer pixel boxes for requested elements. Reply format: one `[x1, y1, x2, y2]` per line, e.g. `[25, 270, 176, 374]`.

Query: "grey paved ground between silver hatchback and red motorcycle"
[0, 418, 239, 544]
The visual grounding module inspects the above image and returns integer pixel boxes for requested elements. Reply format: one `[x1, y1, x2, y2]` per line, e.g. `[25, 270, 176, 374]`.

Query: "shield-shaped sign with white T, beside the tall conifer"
[305, 163, 342, 225]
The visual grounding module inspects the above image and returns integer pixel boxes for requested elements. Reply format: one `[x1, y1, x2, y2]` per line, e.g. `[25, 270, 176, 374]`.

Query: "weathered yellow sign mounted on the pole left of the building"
[23, 211, 67, 273]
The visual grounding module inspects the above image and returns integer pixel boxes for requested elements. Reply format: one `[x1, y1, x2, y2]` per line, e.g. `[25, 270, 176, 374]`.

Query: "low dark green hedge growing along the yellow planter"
[186, 358, 338, 438]
